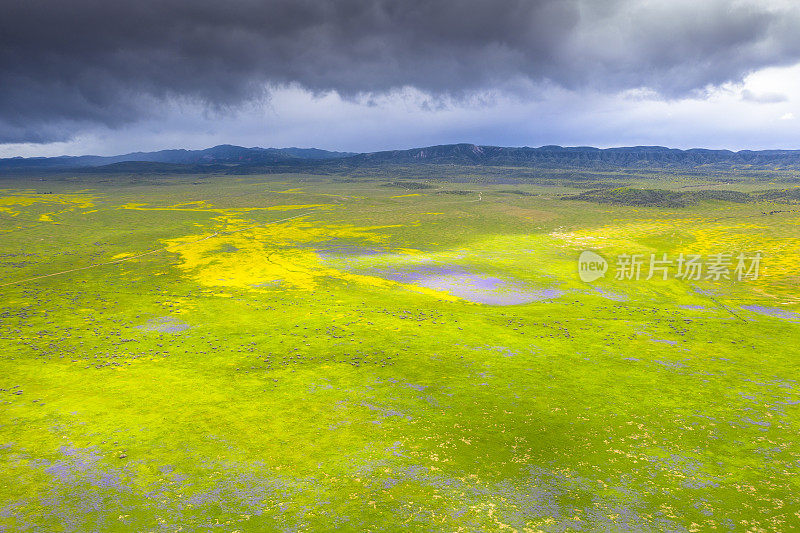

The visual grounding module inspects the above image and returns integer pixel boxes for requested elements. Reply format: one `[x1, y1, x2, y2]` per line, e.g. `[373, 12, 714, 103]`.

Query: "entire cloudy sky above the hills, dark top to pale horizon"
[0, 0, 800, 157]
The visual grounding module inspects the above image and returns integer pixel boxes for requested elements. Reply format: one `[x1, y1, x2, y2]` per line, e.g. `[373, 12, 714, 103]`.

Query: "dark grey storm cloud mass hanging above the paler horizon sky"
[0, 0, 800, 142]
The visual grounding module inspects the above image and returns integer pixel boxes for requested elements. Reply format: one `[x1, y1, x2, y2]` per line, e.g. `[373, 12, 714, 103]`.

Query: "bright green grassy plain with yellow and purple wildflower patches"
[0, 166, 800, 532]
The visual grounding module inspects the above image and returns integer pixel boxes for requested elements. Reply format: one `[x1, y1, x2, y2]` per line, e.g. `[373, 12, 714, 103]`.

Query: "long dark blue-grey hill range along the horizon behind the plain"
[0, 144, 800, 174]
